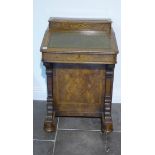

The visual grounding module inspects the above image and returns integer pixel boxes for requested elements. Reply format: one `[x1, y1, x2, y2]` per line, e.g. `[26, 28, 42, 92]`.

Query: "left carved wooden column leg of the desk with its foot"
[44, 63, 56, 132]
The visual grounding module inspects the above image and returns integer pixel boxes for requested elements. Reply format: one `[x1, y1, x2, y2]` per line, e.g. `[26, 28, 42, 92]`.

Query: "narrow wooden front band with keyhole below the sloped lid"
[42, 52, 116, 64]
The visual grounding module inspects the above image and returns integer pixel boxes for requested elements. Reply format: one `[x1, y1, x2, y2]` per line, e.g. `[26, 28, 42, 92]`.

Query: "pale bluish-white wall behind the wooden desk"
[33, 0, 121, 103]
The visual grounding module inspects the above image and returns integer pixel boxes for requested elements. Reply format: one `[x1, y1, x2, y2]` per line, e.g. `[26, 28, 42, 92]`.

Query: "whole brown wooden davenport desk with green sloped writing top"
[41, 18, 118, 133]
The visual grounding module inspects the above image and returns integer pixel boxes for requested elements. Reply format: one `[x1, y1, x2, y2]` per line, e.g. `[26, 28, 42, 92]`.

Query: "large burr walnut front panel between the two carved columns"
[53, 64, 105, 116]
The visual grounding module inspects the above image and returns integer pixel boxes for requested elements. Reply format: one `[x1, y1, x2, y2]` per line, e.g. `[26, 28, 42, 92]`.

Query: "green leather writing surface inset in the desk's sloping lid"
[48, 31, 111, 49]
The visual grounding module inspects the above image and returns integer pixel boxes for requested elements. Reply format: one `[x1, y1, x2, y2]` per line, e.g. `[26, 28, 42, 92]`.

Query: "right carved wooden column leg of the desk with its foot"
[102, 65, 115, 133]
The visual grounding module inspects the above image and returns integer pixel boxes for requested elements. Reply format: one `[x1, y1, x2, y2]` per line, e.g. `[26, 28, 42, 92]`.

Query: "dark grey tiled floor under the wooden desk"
[33, 101, 121, 155]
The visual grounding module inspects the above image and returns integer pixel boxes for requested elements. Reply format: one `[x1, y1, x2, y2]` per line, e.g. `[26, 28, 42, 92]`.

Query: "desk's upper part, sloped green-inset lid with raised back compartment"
[41, 18, 118, 54]
